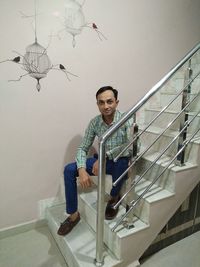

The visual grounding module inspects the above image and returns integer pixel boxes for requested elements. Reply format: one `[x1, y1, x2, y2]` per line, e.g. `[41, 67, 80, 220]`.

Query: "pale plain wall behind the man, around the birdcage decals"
[0, 0, 200, 228]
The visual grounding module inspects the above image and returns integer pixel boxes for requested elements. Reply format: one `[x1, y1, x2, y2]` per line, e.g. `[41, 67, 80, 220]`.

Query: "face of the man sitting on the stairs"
[97, 90, 119, 118]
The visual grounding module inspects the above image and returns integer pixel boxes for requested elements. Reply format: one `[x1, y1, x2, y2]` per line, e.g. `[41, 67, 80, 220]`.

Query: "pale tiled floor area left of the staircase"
[0, 227, 67, 267]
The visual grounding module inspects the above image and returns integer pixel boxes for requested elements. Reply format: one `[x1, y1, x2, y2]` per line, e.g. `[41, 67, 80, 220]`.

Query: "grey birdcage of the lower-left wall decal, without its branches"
[22, 40, 52, 92]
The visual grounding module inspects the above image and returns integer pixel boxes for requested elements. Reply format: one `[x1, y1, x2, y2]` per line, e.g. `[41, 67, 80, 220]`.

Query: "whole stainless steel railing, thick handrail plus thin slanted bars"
[95, 44, 200, 266]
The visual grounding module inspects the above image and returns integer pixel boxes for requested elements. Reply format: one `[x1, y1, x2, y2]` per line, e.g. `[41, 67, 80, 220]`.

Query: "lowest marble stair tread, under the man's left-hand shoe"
[47, 204, 120, 267]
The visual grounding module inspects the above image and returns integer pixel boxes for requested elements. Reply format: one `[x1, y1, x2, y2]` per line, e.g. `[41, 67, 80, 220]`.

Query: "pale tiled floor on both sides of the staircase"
[0, 227, 200, 267]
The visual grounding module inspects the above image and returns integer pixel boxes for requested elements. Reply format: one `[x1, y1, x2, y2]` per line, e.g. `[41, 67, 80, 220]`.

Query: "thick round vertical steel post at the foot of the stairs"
[95, 140, 106, 266]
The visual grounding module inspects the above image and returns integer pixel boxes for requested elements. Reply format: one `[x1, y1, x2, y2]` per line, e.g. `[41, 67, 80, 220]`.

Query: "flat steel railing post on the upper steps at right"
[176, 59, 192, 166]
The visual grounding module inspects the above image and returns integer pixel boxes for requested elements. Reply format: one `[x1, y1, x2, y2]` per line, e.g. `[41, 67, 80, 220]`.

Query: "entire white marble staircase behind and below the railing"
[46, 46, 200, 267]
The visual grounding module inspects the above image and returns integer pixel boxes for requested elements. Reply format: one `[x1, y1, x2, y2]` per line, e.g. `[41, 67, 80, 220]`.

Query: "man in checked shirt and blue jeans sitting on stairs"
[57, 86, 131, 236]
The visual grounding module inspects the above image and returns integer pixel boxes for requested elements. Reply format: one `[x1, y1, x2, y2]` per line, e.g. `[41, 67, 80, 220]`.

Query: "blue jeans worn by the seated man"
[64, 157, 129, 214]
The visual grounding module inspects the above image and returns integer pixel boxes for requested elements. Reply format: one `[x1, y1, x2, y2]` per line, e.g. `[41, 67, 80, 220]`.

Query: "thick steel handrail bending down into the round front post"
[95, 43, 200, 266]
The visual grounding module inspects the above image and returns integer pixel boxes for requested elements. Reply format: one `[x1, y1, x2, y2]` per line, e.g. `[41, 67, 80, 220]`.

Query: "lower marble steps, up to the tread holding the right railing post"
[47, 160, 200, 267]
